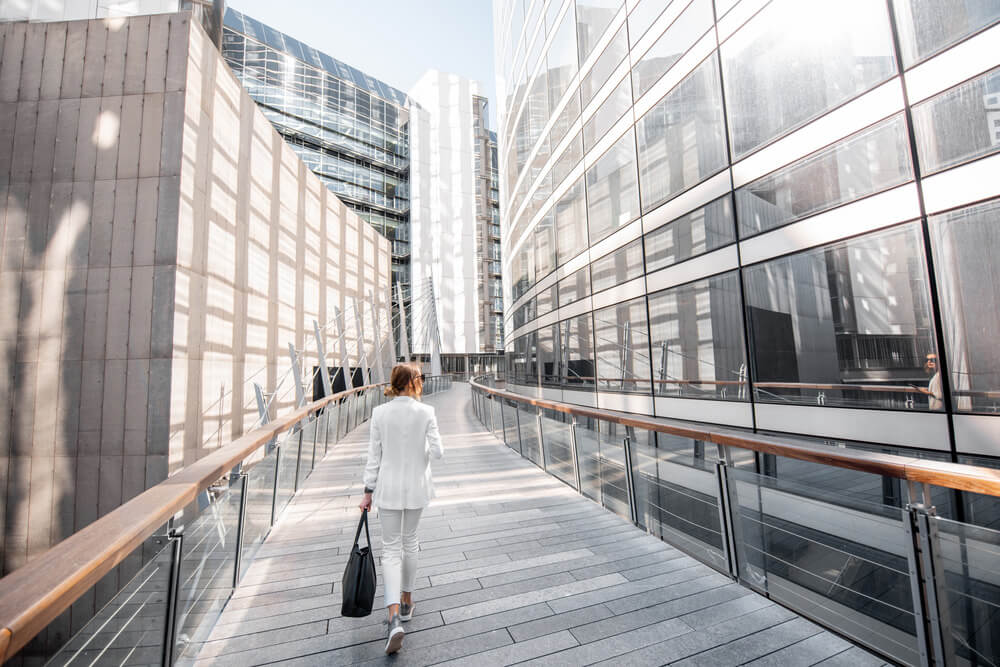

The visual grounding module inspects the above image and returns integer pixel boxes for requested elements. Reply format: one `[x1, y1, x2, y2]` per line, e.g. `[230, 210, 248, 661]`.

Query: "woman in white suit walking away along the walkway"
[360, 364, 444, 654]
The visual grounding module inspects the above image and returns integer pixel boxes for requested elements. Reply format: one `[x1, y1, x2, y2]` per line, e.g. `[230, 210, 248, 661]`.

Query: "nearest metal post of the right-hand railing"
[903, 482, 955, 667]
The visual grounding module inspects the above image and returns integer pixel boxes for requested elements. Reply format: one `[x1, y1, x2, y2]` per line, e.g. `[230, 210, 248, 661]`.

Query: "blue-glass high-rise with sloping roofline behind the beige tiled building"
[222, 9, 410, 344]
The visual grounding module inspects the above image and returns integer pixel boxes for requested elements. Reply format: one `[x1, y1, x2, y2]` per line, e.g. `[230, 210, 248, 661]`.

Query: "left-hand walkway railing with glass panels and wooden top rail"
[0, 376, 452, 666]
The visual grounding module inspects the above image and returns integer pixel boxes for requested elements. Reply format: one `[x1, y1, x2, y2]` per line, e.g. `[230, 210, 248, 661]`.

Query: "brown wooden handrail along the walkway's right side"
[469, 380, 1000, 496]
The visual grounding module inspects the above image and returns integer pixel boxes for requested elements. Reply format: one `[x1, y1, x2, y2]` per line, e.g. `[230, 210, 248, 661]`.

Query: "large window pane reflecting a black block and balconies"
[743, 223, 943, 410]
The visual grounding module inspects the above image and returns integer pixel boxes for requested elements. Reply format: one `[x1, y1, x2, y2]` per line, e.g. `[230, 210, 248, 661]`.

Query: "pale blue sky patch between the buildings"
[226, 0, 497, 130]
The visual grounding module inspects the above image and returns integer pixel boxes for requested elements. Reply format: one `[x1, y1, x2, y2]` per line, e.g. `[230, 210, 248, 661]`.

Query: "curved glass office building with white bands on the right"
[494, 0, 1000, 660]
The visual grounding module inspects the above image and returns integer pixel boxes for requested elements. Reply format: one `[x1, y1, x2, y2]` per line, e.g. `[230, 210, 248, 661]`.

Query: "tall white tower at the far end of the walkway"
[409, 70, 503, 374]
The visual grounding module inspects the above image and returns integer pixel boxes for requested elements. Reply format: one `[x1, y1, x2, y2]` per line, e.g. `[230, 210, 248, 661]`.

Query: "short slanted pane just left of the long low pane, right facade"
[646, 195, 736, 273]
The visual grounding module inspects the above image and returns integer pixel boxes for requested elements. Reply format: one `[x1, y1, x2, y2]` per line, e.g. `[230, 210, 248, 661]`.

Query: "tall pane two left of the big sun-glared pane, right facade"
[584, 130, 639, 243]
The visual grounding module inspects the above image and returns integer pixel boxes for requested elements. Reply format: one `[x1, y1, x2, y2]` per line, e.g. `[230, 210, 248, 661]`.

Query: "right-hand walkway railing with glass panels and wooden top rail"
[470, 377, 1000, 665]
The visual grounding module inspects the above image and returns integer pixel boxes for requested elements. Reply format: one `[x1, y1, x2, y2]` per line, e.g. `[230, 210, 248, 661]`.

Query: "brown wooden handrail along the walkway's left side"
[0, 384, 385, 663]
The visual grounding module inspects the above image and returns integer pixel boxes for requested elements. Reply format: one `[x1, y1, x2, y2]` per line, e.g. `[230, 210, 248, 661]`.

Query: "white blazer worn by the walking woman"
[364, 396, 444, 510]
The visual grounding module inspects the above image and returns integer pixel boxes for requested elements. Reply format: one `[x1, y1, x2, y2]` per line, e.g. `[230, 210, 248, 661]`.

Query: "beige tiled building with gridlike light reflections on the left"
[0, 7, 391, 584]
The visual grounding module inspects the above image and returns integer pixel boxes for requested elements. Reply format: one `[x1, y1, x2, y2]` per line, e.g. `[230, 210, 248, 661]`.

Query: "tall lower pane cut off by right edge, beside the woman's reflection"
[930, 199, 1000, 413]
